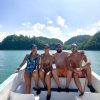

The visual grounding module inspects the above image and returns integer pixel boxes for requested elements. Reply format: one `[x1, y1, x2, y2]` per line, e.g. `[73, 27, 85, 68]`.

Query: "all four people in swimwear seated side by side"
[16, 43, 95, 100]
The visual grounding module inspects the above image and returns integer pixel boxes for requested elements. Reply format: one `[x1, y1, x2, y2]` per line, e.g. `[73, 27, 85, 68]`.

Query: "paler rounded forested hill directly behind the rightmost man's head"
[64, 35, 91, 49]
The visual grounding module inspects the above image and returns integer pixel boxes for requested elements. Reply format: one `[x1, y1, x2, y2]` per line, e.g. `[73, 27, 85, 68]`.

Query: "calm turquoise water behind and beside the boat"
[0, 51, 100, 83]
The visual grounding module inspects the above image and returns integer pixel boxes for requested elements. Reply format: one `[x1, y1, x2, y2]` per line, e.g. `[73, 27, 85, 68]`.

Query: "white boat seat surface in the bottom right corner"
[75, 92, 100, 100]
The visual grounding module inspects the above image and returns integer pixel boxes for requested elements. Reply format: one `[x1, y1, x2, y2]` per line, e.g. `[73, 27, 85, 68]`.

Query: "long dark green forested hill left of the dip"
[0, 35, 63, 50]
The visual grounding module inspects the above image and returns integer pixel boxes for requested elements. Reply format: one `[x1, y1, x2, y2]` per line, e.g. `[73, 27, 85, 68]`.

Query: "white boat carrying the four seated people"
[0, 66, 100, 100]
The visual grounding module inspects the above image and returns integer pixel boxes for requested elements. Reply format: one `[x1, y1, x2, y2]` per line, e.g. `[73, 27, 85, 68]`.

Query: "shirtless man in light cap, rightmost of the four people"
[69, 44, 95, 96]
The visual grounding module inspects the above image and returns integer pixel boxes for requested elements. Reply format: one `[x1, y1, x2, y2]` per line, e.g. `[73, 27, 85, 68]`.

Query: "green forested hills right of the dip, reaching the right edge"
[64, 32, 100, 50]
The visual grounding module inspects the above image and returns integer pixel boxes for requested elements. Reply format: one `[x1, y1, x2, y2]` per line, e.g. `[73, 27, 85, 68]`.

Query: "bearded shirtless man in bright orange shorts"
[52, 43, 72, 92]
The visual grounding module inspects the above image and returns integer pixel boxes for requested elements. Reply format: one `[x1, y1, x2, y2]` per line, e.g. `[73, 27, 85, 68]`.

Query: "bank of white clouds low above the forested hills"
[0, 16, 100, 42]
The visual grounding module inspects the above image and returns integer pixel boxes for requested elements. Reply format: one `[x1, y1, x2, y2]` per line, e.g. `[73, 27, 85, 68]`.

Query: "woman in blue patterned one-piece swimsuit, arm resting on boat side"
[16, 45, 40, 94]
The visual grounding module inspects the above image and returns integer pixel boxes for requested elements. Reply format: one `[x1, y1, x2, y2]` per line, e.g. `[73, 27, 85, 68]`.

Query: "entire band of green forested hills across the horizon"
[0, 32, 100, 50]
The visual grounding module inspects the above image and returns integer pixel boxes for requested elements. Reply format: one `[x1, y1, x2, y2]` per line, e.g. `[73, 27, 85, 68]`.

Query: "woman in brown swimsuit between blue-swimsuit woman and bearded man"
[40, 45, 52, 100]
